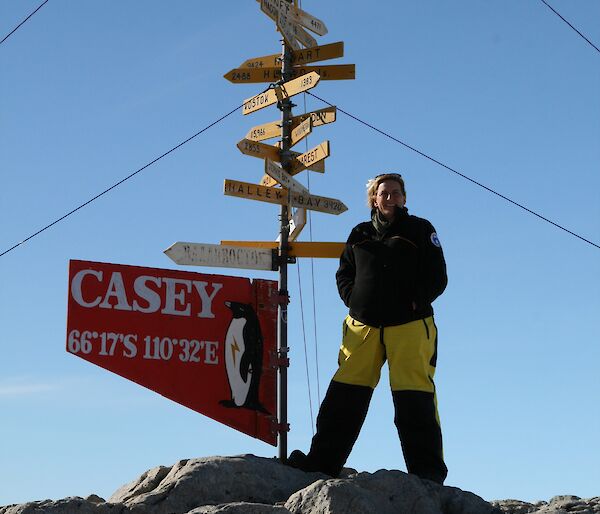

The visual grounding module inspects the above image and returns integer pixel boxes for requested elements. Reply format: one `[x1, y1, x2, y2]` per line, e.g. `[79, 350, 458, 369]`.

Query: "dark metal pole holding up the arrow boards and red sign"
[278, 39, 292, 462]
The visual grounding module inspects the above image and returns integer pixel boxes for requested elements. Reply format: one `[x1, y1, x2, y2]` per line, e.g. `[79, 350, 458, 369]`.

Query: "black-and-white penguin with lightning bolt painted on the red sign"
[219, 302, 270, 414]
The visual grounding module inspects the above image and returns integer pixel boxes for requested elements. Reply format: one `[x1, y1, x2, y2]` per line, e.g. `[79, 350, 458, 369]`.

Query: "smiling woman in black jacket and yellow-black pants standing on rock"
[288, 173, 448, 484]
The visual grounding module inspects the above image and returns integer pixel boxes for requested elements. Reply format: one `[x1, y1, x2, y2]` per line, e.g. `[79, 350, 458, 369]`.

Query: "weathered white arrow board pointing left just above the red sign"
[164, 242, 277, 271]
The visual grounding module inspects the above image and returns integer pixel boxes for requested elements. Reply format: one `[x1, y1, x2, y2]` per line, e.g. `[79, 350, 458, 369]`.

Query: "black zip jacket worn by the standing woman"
[336, 208, 448, 327]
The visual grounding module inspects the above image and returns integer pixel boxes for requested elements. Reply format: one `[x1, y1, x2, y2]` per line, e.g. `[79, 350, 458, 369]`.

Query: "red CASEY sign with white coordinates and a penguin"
[67, 261, 277, 446]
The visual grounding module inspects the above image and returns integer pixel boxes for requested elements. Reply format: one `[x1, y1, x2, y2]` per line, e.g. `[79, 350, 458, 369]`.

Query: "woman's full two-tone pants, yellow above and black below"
[302, 316, 448, 484]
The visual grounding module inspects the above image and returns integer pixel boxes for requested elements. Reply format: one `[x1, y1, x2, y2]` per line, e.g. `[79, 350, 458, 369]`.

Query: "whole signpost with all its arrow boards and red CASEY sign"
[66, 0, 355, 461]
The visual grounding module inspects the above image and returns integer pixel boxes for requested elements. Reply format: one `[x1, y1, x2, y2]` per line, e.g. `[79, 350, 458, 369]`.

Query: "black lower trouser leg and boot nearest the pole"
[289, 381, 373, 477]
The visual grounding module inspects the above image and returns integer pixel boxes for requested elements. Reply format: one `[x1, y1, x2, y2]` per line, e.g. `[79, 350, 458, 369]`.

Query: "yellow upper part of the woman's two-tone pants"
[333, 316, 437, 393]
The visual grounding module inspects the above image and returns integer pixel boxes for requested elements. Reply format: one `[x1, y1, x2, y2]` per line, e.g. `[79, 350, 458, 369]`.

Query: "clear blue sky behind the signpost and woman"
[0, 0, 600, 505]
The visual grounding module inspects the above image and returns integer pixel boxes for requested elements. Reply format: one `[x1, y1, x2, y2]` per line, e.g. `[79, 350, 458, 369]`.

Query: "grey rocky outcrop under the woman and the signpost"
[0, 455, 600, 514]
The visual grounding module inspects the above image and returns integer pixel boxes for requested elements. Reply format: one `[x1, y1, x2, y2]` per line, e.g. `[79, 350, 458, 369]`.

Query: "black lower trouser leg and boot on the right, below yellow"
[392, 391, 448, 484]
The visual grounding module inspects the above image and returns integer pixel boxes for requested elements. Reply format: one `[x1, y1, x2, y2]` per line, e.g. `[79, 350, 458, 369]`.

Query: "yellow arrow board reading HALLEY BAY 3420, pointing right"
[223, 179, 348, 214]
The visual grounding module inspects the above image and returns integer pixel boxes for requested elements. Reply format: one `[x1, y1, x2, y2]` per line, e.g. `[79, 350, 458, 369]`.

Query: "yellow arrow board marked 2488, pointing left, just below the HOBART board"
[223, 64, 356, 84]
